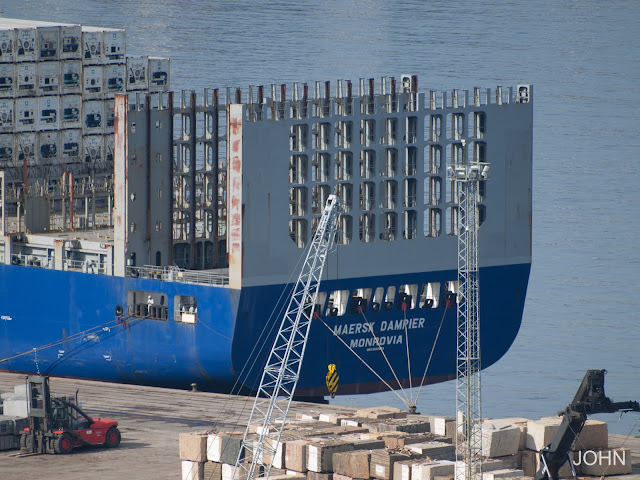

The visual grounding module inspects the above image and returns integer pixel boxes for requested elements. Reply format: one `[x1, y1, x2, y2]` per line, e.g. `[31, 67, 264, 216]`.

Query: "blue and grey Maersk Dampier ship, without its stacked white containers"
[0, 21, 533, 397]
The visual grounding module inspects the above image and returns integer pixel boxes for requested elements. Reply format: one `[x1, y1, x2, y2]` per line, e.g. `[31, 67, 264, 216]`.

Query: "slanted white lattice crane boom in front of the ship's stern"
[233, 195, 340, 480]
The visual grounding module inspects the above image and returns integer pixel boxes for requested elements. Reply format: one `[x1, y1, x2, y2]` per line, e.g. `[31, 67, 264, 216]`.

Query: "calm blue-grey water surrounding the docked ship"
[0, 0, 640, 434]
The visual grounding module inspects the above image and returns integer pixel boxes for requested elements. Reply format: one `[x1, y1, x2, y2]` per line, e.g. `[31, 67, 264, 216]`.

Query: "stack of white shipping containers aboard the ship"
[0, 18, 169, 182]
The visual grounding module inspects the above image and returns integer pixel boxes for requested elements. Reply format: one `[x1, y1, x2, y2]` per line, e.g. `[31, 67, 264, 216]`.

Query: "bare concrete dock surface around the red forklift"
[0, 372, 640, 480]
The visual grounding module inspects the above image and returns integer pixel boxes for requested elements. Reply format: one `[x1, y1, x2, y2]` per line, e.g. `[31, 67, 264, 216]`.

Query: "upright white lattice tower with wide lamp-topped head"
[447, 157, 489, 480]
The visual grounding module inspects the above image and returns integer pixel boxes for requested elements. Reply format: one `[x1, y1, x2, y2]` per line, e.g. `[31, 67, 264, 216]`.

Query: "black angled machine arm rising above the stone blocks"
[534, 370, 640, 480]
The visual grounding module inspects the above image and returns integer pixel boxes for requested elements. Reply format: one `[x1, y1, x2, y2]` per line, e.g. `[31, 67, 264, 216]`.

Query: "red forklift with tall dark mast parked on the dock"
[20, 375, 120, 454]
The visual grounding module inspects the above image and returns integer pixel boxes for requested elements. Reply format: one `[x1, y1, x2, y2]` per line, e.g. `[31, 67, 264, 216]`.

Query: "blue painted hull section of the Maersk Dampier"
[0, 264, 530, 396]
